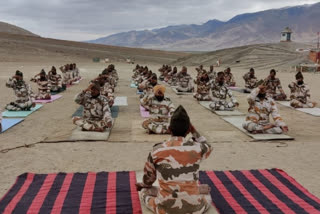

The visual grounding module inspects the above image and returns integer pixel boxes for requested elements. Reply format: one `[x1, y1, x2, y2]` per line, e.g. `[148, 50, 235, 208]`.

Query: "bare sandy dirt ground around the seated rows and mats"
[0, 60, 320, 213]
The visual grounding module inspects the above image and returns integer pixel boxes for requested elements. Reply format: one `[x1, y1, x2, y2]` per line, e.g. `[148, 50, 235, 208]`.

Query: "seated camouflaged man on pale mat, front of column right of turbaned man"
[243, 85, 288, 134]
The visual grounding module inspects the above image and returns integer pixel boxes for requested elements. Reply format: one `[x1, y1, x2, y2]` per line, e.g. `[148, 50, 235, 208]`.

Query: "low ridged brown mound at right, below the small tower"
[174, 43, 310, 69]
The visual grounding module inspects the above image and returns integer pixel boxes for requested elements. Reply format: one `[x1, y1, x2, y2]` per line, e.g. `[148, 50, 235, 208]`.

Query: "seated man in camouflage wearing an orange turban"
[142, 85, 175, 134]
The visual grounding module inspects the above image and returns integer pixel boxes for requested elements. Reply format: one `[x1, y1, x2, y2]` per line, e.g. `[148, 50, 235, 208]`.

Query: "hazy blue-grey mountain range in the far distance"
[90, 3, 320, 51]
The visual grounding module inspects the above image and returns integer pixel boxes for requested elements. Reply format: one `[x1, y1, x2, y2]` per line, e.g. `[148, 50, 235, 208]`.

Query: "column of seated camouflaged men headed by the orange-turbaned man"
[133, 66, 175, 134]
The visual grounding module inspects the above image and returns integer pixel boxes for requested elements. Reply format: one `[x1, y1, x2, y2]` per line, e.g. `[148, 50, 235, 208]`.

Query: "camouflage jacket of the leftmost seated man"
[6, 78, 33, 103]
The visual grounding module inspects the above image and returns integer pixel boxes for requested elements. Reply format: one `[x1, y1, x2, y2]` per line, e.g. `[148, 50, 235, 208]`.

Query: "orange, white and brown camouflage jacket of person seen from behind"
[143, 136, 212, 213]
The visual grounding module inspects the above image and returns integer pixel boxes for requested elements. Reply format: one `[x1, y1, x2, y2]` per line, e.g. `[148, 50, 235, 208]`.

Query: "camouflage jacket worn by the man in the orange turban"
[142, 96, 175, 119]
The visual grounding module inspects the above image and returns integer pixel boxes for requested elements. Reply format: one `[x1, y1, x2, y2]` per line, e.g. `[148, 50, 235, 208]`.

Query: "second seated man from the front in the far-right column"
[264, 69, 287, 101]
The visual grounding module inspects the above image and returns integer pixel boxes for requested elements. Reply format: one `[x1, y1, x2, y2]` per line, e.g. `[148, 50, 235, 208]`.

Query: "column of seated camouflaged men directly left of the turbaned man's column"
[72, 65, 119, 132]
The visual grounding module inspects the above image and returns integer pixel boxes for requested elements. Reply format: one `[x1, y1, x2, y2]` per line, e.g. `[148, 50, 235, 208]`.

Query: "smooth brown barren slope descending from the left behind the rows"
[0, 33, 188, 63]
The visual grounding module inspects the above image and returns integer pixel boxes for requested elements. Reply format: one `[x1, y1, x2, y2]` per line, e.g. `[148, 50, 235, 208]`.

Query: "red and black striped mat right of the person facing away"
[199, 169, 320, 214]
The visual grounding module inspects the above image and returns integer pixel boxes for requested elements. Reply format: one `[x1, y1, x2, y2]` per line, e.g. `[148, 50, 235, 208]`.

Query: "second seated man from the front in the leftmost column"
[30, 69, 51, 100]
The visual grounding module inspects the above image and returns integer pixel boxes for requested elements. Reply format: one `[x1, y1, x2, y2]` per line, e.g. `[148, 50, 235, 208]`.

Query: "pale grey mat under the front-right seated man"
[222, 116, 294, 141]
